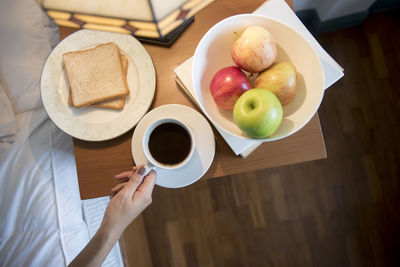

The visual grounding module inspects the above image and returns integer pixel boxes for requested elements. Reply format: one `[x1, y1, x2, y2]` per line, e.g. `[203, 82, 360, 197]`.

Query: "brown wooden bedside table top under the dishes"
[60, 0, 326, 199]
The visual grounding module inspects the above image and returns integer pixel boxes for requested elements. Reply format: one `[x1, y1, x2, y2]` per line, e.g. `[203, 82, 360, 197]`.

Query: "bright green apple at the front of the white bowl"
[233, 88, 283, 138]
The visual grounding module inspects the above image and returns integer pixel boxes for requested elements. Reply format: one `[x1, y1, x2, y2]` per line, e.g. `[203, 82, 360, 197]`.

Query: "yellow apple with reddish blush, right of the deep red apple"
[254, 61, 296, 106]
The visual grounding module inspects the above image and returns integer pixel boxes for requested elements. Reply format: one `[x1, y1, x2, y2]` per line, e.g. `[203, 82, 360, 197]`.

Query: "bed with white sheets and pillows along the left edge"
[0, 0, 122, 266]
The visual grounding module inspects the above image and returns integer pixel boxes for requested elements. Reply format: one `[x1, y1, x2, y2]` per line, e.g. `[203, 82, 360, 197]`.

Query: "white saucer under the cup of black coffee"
[132, 104, 215, 188]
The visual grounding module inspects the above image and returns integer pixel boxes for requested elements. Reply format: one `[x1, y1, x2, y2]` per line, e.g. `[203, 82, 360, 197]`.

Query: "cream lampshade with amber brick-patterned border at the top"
[39, 0, 214, 45]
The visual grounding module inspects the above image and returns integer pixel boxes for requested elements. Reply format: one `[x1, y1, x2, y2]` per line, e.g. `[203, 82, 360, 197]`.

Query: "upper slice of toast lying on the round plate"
[63, 42, 129, 108]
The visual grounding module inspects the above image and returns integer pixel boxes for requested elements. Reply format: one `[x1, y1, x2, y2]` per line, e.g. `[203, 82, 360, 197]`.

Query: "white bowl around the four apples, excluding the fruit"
[192, 14, 324, 142]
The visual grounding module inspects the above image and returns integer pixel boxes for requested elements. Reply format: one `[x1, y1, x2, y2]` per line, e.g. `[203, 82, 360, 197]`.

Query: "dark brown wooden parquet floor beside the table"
[124, 10, 400, 267]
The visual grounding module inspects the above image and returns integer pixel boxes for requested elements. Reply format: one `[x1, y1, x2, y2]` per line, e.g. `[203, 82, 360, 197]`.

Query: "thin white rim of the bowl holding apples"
[191, 14, 325, 142]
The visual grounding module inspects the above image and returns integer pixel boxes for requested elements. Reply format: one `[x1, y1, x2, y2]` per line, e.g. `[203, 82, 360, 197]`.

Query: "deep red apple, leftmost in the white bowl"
[210, 66, 251, 110]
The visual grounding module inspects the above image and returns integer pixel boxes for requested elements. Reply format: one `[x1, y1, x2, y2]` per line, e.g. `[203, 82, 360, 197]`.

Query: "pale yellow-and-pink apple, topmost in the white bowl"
[231, 26, 277, 73]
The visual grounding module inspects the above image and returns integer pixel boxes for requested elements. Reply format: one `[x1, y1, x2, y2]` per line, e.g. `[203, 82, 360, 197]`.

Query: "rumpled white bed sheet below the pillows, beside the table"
[0, 108, 89, 266]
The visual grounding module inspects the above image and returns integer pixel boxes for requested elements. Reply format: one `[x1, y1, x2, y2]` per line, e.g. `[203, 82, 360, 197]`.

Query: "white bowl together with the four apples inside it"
[192, 14, 324, 142]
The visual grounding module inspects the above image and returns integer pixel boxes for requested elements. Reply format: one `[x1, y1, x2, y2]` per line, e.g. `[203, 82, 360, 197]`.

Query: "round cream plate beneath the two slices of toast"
[40, 30, 156, 141]
